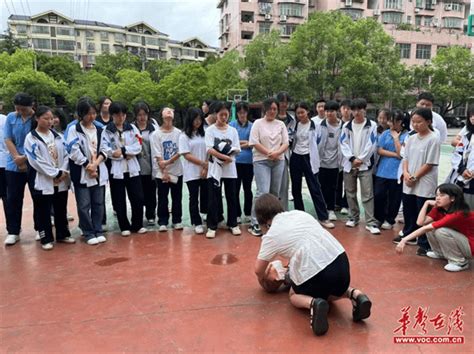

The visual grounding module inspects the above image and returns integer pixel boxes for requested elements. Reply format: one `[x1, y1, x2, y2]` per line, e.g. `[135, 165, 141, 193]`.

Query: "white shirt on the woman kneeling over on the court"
[257, 210, 344, 285]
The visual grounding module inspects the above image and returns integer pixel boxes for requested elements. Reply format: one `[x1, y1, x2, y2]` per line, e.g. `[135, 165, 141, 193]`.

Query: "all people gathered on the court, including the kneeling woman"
[0, 92, 474, 335]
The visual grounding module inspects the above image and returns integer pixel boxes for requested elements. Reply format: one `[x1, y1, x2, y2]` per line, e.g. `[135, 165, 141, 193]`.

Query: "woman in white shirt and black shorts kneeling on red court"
[255, 194, 372, 335]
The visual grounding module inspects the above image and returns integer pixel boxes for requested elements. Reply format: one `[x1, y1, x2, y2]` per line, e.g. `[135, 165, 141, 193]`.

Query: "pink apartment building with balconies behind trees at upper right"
[217, 0, 474, 65]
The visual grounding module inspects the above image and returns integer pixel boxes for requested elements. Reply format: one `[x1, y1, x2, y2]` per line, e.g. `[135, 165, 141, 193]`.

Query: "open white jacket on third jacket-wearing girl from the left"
[102, 122, 142, 179]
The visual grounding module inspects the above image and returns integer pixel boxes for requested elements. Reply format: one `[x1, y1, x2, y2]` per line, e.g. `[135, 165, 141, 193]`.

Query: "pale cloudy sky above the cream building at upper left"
[0, 0, 220, 47]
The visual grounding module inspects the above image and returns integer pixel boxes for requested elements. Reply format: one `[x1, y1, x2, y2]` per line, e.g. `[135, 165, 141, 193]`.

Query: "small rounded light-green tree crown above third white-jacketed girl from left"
[107, 69, 160, 107]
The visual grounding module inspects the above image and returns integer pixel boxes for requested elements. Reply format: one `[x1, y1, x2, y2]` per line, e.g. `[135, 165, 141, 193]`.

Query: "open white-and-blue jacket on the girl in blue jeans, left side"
[66, 123, 109, 188]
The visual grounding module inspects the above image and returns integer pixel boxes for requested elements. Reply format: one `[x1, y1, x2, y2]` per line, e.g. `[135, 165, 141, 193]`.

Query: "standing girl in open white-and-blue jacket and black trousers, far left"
[25, 106, 76, 250]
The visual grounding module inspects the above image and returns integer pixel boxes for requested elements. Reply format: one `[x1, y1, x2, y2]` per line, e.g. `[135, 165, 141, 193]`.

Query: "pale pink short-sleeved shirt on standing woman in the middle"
[249, 118, 288, 162]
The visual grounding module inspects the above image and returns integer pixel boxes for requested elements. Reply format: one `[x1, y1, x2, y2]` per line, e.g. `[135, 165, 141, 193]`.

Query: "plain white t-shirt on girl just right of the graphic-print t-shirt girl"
[179, 133, 207, 182]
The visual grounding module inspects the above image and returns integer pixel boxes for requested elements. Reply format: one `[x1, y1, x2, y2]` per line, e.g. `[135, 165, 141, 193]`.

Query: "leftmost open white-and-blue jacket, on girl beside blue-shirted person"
[24, 130, 70, 195]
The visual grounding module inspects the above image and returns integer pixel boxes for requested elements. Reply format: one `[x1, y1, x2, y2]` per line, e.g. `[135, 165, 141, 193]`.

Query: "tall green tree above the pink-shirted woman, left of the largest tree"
[244, 31, 290, 101]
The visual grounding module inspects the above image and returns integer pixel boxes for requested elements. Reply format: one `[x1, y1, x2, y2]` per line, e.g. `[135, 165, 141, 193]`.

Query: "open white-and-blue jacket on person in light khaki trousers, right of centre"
[339, 118, 377, 172]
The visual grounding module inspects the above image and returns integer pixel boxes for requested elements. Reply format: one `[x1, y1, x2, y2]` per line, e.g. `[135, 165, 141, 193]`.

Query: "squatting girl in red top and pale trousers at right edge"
[396, 183, 474, 272]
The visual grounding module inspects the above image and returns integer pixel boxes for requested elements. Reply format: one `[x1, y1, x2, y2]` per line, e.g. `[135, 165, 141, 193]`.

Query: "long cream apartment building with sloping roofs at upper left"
[8, 11, 219, 68]
